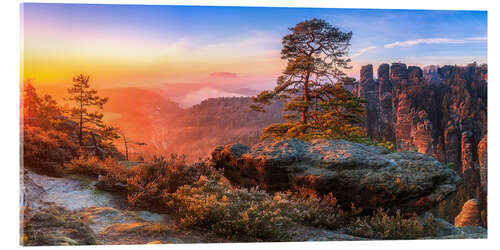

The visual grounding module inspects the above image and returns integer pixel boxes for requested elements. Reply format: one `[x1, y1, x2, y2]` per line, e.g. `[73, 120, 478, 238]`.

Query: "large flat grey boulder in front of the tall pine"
[212, 139, 461, 213]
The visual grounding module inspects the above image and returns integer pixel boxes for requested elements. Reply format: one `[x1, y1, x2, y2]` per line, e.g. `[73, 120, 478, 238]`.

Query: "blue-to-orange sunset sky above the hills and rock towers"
[23, 4, 487, 94]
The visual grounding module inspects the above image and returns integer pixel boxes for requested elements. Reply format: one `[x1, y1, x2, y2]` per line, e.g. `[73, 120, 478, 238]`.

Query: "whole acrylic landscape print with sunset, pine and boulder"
[20, 3, 488, 246]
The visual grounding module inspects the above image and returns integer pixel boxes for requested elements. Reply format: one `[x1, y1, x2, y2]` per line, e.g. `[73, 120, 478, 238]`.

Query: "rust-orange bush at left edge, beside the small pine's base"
[22, 126, 80, 176]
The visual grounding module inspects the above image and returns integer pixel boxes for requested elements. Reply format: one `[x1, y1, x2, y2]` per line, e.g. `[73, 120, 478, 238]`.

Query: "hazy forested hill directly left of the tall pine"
[160, 97, 283, 160]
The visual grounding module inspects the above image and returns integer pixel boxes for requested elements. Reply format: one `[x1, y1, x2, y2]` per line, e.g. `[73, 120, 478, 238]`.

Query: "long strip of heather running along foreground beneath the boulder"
[163, 176, 438, 241]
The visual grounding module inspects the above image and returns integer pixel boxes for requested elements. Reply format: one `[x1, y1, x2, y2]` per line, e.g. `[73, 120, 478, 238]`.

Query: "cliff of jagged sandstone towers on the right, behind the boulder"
[358, 63, 487, 222]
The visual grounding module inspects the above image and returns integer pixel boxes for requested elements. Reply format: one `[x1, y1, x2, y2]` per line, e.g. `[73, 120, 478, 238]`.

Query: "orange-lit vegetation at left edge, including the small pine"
[21, 76, 121, 176]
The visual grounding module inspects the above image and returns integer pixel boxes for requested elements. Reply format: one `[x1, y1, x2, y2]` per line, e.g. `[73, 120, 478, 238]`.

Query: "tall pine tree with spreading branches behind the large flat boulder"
[251, 19, 364, 139]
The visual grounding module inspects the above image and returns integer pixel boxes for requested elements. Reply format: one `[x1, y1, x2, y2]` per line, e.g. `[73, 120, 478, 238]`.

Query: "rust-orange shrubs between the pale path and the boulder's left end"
[64, 155, 220, 209]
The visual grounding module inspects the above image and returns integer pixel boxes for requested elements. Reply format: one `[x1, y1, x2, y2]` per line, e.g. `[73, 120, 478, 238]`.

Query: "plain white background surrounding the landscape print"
[0, 0, 500, 250]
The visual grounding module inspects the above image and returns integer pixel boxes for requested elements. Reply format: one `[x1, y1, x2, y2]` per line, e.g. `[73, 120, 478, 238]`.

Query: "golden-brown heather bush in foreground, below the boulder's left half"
[163, 176, 293, 241]
